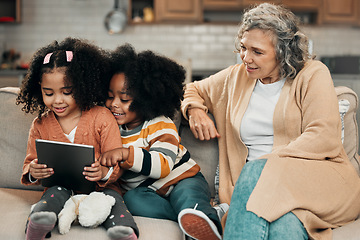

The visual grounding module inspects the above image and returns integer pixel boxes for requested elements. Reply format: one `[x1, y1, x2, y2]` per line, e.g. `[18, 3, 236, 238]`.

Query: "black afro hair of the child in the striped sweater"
[108, 44, 186, 120]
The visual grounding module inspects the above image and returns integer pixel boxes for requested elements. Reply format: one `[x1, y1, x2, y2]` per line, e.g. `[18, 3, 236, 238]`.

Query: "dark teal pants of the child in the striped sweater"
[124, 172, 222, 234]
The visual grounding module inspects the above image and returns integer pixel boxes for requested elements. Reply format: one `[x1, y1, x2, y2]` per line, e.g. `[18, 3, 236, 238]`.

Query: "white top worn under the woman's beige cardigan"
[240, 78, 285, 161]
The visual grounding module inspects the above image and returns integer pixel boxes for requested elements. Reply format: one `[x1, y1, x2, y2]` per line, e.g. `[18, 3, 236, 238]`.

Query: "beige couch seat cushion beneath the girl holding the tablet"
[0, 188, 185, 240]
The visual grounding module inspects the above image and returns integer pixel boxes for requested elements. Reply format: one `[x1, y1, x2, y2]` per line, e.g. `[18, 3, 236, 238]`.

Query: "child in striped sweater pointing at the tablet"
[100, 44, 228, 240]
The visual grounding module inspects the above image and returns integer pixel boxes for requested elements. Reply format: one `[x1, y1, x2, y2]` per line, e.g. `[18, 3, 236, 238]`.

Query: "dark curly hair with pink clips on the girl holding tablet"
[16, 37, 109, 118]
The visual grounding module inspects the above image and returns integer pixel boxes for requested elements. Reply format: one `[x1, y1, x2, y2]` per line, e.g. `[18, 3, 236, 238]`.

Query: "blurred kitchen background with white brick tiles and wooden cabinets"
[0, 0, 360, 84]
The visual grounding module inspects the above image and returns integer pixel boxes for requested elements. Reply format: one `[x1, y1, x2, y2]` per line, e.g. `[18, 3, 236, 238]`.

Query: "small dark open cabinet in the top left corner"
[0, 0, 21, 23]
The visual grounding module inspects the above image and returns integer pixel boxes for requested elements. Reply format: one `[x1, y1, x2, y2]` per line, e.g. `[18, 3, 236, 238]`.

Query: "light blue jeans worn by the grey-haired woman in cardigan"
[223, 159, 308, 240]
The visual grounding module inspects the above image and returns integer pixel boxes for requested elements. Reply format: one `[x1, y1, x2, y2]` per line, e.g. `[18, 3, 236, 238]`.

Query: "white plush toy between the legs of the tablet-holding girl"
[58, 192, 115, 234]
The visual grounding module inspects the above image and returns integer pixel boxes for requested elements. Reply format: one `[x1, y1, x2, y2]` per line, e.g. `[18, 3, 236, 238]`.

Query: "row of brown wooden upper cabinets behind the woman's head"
[128, 0, 360, 26]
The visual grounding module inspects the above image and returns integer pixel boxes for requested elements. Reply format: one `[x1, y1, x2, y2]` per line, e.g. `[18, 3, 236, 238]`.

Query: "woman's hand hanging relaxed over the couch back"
[187, 108, 220, 140]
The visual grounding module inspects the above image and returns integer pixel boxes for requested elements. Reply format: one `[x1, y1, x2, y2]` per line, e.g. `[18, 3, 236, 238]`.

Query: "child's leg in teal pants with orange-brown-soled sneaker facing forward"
[170, 172, 222, 240]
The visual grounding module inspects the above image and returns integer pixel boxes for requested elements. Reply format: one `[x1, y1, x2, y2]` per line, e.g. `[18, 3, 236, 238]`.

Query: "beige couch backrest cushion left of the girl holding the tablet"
[0, 88, 42, 189]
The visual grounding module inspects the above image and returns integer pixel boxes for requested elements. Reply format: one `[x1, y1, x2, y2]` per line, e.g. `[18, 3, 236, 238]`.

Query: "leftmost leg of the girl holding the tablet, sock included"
[25, 186, 72, 240]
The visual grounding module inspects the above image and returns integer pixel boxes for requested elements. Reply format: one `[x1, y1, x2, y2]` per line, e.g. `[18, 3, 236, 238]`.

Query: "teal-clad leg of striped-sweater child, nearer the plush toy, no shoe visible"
[124, 187, 177, 222]
